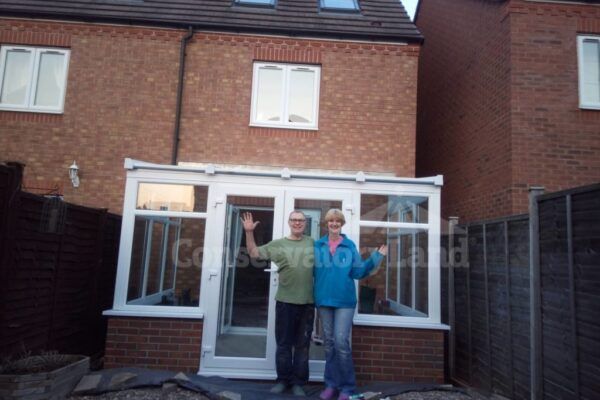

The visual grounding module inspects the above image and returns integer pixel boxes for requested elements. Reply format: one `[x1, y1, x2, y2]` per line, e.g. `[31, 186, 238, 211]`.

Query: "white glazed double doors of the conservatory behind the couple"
[200, 185, 352, 380]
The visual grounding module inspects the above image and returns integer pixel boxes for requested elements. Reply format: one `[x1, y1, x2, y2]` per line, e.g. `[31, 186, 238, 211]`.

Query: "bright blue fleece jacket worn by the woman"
[314, 234, 383, 308]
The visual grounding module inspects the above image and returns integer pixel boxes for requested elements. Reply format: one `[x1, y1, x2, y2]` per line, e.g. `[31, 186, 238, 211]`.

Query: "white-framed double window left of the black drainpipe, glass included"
[0, 46, 69, 113]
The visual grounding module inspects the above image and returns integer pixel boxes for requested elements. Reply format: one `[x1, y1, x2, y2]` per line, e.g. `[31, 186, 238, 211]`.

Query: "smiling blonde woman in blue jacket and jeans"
[314, 208, 387, 400]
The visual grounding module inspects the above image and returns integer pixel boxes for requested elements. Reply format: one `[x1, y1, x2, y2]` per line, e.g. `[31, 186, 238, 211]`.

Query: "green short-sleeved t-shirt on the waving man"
[258, 236, 315, 304]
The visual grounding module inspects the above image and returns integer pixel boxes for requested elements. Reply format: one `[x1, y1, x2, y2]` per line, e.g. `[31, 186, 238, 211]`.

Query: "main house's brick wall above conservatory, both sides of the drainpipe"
[0, 20, 420, 212]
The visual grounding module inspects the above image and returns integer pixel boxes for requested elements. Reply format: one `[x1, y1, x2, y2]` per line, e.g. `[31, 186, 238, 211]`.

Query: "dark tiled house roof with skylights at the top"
[0, 0, 423, 42]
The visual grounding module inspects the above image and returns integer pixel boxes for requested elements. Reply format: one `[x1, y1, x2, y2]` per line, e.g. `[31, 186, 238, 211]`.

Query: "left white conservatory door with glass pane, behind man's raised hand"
[200, 185, 284, 379]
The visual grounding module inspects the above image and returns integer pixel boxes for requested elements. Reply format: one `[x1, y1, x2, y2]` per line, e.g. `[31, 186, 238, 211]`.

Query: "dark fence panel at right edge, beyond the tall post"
[538, 185, 600, 399]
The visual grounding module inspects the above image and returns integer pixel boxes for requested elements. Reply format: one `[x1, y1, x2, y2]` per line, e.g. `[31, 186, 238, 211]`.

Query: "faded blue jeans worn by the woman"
[319, 307, 356, 394]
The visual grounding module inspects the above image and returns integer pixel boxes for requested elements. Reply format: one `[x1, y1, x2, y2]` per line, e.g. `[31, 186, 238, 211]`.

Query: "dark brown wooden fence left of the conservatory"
[0, 164, 121, 357]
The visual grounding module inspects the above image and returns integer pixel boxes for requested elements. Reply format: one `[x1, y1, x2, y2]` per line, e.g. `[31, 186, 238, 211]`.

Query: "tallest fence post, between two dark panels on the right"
[529, 186, 544, 400]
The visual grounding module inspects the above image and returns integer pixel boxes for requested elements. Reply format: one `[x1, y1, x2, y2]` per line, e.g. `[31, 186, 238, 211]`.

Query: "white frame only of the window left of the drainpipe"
[0, 46, 71, 114]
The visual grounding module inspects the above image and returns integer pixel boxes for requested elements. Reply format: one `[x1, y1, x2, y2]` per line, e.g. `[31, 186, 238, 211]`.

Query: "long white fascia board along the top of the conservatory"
[125, 158, 444, 186]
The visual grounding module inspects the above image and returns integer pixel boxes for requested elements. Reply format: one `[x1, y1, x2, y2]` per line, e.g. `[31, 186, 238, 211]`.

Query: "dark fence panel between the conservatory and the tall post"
[449, 215, 530, 399]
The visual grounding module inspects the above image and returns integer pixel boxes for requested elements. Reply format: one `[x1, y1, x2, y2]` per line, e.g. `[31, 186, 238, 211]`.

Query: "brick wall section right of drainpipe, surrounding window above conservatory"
[180, 34, 419, 176]
